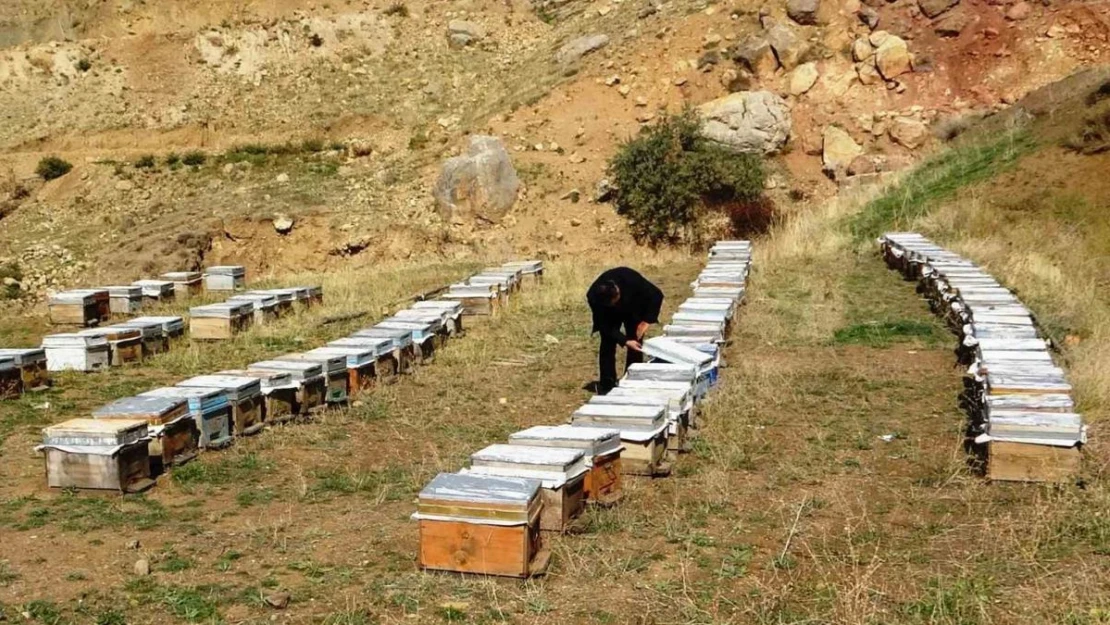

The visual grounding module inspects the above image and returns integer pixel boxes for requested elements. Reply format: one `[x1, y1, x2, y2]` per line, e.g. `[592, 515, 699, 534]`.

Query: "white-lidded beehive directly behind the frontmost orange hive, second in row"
[468, 444, 589, 532]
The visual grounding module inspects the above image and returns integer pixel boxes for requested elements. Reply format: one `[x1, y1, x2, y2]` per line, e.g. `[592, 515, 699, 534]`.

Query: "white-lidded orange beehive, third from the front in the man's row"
[508, 425, 624, 505]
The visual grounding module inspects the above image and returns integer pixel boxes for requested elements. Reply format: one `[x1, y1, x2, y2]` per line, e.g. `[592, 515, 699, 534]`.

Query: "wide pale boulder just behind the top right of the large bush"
[698, 91, 790, 154]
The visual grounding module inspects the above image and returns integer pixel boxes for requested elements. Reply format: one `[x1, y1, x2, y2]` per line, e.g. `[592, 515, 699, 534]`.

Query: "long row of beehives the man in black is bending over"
[413, 241, 750, 577]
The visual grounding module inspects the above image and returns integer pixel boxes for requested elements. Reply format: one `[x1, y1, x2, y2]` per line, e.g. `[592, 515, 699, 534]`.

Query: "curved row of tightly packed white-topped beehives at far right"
[879, 232, 1087, 482]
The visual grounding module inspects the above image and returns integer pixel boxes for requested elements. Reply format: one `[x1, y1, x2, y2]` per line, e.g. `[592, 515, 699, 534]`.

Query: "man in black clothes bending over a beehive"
[586, 266, 663, 395]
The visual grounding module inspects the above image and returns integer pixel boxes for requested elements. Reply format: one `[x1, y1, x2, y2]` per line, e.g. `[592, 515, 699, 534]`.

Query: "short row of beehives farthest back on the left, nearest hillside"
[47, 265, 246, 327]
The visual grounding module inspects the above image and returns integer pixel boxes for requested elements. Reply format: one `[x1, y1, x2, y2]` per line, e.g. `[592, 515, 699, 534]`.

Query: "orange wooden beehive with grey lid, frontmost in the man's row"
[413, 473, 551, 577]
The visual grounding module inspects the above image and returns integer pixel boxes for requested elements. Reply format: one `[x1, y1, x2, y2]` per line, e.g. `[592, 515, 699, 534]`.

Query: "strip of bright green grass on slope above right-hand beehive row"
[849, 132, 1036, 242]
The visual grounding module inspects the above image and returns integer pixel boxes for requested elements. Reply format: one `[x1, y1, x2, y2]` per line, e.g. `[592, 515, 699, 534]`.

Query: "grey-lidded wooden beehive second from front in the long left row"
[92, 396, 200, 474]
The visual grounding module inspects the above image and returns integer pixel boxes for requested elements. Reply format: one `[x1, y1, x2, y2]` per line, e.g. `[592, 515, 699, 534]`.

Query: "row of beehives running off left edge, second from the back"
[0, 286, 323, 399]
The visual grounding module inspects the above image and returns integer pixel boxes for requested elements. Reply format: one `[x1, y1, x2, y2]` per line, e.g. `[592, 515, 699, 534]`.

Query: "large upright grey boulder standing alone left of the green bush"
[434, 134, 521, 223]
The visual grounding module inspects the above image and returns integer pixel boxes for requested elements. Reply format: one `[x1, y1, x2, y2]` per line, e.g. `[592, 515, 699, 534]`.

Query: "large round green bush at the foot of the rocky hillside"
[609, 110, 769, 245]
